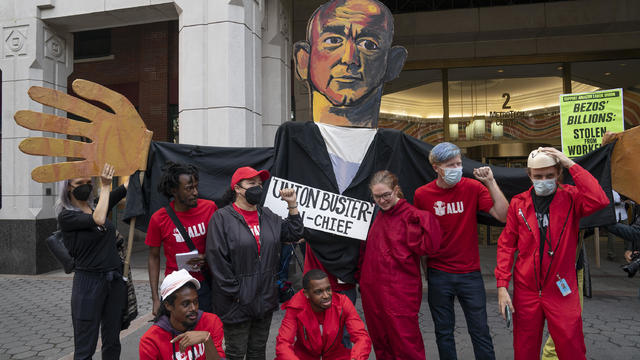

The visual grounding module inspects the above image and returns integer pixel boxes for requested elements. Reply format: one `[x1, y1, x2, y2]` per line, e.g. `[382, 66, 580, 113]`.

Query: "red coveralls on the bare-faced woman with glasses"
[360, 199, 441, 360]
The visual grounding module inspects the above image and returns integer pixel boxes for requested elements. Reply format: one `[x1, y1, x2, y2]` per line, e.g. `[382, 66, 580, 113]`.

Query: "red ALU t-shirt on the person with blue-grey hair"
[413, 177, 493, 274]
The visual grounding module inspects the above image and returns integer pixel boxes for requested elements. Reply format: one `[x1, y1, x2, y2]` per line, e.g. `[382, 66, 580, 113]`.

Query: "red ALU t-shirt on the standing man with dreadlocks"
[144, 199, 218, 281]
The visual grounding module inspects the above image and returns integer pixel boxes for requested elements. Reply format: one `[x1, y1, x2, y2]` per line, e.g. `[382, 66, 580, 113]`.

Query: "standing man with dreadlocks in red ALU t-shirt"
[144, 161, 218, 315]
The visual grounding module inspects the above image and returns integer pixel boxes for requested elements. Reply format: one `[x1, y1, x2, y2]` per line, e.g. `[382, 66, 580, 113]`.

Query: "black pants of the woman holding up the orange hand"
[71, 271, 127, 360]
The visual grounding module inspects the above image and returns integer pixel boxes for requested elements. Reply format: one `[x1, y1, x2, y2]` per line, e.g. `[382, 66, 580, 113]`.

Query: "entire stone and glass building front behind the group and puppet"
[0, 0, 640, 274]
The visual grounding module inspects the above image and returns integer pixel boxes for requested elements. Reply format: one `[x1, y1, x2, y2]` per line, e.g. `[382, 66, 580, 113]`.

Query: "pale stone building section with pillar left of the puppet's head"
[0, 0, 291, 274]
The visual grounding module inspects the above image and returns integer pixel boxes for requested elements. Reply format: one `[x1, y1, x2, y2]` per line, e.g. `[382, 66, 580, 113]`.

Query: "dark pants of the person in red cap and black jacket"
[223, 313, 273, 360]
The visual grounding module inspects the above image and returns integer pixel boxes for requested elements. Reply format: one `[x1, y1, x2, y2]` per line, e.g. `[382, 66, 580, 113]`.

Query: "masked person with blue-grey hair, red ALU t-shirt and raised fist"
[414, 142, 508, 359]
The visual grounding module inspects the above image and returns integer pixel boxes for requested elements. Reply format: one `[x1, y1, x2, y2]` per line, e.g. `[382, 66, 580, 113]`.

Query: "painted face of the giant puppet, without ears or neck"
[309, 0, 393, 106]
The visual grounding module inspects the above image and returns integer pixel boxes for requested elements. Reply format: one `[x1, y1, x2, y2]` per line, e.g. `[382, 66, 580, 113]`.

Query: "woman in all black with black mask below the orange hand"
[56, 164, 128, 360]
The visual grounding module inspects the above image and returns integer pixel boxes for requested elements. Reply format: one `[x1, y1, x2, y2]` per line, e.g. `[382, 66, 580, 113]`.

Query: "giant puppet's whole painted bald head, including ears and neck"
[294, 0, 407, 126]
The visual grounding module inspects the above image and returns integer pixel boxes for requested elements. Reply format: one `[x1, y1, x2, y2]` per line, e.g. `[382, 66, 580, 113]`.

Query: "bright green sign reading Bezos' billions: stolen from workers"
[560, 89, 624, 157]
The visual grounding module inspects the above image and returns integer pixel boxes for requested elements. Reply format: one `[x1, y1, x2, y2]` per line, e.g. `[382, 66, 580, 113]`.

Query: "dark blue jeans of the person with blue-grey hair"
[428, 268, 496, 360]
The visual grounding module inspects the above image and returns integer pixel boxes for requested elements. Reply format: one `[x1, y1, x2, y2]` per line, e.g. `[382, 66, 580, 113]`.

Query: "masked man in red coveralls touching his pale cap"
[495, 148, 609, 360]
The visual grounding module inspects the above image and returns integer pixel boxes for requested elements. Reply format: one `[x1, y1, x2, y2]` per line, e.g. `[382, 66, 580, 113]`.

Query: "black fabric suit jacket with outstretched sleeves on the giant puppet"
[125, 122, 615, 282]
